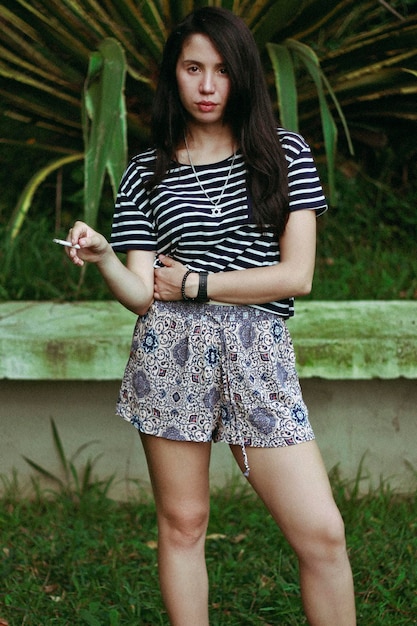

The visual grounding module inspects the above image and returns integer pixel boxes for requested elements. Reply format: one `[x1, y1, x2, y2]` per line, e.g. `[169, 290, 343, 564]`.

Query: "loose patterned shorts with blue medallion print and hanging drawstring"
[117, 302, 314, 470]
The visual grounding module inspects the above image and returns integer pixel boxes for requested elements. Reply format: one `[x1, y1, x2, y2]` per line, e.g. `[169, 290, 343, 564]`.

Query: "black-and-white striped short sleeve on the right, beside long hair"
[280, 131, 327, 216]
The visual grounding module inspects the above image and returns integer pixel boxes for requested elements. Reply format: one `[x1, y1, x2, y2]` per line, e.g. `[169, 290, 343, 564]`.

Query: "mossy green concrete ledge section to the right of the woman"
[289, 301, 417, 380]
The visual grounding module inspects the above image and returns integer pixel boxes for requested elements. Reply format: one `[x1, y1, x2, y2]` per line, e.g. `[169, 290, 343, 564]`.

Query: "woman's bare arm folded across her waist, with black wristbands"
[155, 210, 316, 304]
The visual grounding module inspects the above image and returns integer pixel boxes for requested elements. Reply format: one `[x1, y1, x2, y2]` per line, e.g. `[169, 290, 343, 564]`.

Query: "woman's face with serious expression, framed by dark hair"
[176, 34, 230, 125]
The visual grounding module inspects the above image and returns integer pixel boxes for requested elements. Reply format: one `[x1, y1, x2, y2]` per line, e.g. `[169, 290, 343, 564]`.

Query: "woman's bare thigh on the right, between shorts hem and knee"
[232, 441, 343, 549]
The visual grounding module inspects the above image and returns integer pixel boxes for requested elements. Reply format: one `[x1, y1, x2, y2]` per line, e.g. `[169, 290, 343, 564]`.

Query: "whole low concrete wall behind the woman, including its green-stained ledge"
[0, 302, 417, 499]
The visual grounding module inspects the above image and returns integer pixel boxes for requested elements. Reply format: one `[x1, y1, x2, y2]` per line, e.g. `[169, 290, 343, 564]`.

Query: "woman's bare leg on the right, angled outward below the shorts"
[232, 441, 356, 626]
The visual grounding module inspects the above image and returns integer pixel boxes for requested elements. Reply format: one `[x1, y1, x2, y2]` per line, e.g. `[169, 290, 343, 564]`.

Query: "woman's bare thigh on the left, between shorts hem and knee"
[141, 434, 211, 517]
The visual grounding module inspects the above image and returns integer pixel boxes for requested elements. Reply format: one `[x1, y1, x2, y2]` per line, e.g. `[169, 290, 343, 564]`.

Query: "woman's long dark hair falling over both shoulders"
[148, 7, 288, 236]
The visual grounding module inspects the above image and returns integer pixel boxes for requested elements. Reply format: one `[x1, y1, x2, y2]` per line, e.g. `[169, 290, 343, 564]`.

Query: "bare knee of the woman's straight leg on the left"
[159, 504, 209, 548]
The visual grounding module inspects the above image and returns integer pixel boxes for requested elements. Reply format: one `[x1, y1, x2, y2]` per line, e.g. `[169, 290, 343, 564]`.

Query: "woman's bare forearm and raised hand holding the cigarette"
[66, 222, 154, 315]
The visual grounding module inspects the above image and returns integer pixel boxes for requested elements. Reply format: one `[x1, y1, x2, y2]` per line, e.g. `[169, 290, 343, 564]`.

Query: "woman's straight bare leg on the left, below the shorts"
[141, 435, 211, 626]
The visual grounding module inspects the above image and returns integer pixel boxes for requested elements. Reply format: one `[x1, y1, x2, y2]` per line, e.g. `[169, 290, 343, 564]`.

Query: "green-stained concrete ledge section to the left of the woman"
[0, 301, 135, 380]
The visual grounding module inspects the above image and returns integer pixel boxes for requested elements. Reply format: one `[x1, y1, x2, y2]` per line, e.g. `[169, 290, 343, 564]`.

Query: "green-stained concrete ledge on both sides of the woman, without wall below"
[0, 300, 417, 381]
